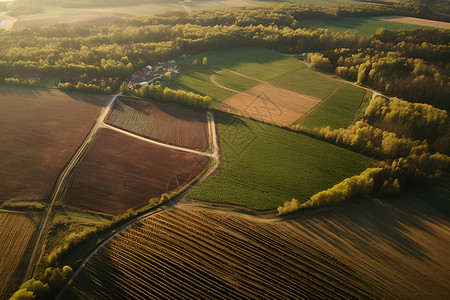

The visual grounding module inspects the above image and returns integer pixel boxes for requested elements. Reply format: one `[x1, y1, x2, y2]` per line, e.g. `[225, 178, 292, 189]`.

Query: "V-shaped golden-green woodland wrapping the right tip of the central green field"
[278, 97, 450, 214]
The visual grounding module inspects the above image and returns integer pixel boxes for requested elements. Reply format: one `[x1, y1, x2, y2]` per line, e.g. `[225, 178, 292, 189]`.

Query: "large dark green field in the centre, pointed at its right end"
[190, 113, 373, 210]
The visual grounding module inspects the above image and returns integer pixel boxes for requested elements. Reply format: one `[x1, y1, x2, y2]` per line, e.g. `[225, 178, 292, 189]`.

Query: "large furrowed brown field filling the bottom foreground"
[63, 199, 450, 299]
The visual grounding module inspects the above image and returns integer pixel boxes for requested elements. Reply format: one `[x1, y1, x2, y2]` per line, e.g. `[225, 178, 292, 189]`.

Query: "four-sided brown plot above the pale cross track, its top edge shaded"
[105, 97, 209, 151]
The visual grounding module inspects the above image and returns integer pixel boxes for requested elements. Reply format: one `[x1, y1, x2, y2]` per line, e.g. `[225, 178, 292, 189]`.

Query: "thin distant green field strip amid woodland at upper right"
[300, 17, 429, 36]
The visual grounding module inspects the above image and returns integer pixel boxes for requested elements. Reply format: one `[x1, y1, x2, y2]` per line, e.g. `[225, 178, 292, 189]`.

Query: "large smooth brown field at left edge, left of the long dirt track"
[0, 86, 108, 202]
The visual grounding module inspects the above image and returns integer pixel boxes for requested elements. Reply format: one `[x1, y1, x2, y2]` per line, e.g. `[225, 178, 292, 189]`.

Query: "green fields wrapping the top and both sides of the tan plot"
[170, 48, 371, 129]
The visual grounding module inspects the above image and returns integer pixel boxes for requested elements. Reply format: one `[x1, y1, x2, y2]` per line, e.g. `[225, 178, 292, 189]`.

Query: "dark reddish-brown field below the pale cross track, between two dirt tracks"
[63, 129, 209, 214]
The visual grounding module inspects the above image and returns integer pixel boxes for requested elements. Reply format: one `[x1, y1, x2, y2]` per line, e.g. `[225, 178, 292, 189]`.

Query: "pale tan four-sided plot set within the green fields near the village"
[216, 83, 322, 126]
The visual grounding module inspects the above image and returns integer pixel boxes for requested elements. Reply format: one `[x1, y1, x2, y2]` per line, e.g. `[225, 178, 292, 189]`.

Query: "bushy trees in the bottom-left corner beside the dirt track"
[11, 266, 73, 300]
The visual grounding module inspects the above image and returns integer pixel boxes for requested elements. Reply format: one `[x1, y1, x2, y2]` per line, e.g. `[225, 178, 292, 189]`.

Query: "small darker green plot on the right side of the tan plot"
[296, 84, 372, 129]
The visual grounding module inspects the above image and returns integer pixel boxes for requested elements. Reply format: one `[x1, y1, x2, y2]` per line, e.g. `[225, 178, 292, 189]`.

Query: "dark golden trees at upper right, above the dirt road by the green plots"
[322, 29, 450, 109]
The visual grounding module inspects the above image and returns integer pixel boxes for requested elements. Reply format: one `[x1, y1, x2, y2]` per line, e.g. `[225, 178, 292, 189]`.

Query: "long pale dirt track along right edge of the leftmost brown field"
[24, 93, 122, 282]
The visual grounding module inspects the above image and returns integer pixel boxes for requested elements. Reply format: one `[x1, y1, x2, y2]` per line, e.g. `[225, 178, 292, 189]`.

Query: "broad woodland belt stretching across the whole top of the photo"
[0, 3, 450, 109]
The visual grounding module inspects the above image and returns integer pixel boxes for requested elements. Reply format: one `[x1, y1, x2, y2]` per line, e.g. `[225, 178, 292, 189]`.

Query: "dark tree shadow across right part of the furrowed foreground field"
[284, 197, 450, 264]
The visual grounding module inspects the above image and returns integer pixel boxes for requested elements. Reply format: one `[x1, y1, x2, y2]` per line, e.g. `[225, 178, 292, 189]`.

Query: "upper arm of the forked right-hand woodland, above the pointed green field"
[294, 96, 450, 159]
